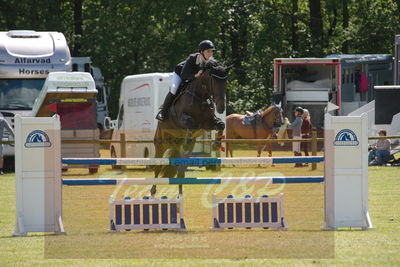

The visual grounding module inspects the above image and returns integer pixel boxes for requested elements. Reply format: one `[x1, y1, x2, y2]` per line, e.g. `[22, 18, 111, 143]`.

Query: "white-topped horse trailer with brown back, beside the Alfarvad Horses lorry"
[32, 72, 100, 174]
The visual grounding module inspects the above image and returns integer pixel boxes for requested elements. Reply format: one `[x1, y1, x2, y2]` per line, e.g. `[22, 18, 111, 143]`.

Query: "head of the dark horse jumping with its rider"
[203, 61, 228, 113]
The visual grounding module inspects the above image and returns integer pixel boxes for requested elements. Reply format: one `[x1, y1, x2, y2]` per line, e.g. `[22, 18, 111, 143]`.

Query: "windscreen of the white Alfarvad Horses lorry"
[0, 79, 45, 110]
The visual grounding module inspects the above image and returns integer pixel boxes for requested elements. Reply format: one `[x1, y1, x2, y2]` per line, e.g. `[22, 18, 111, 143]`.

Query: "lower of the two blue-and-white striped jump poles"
[62, 176, 324, 186]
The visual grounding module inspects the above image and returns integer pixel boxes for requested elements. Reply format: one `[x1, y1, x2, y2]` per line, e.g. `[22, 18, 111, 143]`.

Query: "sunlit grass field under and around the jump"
[0, 151, 400, 266]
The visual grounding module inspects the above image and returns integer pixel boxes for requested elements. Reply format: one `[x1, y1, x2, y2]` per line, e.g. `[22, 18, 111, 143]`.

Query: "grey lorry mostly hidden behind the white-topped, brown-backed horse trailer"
[72, 57, 110, 130]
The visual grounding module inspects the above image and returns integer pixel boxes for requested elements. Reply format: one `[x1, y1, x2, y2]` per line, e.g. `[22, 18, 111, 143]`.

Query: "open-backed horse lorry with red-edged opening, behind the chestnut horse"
[273, 54, 393, 129]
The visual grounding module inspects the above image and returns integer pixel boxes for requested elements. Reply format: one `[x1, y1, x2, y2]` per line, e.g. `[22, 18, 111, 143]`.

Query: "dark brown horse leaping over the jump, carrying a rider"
[150, 61, 228, 196]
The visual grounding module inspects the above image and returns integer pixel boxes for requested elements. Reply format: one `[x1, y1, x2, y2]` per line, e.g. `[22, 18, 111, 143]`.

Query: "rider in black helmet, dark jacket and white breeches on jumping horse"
[156, 40, 215, 121]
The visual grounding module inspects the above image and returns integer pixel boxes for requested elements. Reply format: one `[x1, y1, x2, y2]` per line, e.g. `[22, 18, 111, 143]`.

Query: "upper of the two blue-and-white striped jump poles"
[62, 156, 324, 166]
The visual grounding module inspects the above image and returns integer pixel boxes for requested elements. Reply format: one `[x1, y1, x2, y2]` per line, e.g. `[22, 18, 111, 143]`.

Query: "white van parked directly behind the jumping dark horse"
[110, 73, 225, 162]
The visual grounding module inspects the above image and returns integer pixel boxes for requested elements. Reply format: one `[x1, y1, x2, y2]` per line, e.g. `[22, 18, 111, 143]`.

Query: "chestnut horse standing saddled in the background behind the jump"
[226, 105, 283, 157]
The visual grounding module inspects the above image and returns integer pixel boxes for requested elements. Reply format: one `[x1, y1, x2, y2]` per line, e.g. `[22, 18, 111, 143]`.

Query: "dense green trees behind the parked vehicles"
[0, 0, 400, 118]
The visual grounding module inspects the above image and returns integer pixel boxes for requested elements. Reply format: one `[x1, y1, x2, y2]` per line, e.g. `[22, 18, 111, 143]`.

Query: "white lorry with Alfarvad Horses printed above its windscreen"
[0, 30, 72, 166]
